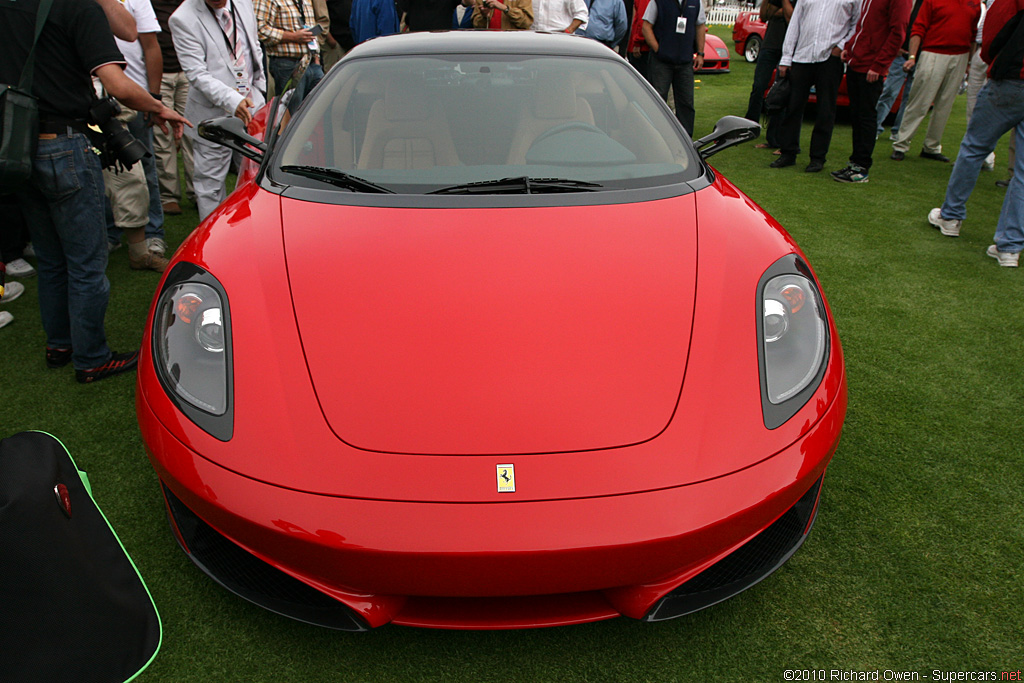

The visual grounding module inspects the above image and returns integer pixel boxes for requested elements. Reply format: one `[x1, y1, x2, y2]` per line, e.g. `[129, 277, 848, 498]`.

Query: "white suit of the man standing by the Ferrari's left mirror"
[170, 0, 266, 220]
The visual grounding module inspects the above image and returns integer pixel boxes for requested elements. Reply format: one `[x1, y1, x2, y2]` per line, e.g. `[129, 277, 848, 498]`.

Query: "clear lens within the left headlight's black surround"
[153, 281, 228, 419]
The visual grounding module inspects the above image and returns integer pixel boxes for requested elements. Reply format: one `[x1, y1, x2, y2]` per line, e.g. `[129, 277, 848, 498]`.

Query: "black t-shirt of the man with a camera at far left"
[0, 0, 124, 119]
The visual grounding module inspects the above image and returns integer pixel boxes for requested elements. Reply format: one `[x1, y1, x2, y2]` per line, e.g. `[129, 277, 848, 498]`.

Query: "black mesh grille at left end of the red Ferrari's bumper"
[164, 486, 367, 631]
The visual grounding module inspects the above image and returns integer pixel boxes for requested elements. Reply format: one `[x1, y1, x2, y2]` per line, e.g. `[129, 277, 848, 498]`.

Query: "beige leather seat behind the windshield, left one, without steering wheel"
[358, 75, 459, 169]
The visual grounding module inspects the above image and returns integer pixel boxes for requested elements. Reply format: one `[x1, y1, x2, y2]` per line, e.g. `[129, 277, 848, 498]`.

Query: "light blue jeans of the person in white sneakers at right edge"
[942, 80, 1024, 253]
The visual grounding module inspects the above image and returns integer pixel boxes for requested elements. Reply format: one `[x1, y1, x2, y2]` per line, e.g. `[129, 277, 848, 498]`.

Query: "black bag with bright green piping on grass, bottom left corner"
[0, 432, 162, 683]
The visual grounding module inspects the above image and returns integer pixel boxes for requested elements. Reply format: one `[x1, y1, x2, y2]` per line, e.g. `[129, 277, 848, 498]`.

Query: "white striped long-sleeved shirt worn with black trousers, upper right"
[779, 0, 861, 67]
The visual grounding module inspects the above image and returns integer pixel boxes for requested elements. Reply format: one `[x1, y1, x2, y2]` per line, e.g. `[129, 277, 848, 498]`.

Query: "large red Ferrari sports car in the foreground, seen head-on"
[136, 32, 847, 630]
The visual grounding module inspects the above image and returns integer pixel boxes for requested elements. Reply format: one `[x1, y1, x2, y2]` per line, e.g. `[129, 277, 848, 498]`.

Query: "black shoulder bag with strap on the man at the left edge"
[0, 0, 53, 193]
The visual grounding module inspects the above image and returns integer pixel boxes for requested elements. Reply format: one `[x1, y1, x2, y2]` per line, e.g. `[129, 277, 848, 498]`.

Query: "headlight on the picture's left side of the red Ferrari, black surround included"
[153, 263, 231, 440]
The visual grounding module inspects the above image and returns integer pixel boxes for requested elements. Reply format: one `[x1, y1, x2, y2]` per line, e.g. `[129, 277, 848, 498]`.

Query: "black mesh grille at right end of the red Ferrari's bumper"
[645, 477, 821, 622]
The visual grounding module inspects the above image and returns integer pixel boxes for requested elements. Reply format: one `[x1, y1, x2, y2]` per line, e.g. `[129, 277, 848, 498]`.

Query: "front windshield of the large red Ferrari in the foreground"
[270, 54, 700, 195]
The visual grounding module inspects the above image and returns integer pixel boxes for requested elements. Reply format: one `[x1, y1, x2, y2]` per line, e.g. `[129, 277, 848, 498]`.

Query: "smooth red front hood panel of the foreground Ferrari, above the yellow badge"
[282, 195, 696, 455]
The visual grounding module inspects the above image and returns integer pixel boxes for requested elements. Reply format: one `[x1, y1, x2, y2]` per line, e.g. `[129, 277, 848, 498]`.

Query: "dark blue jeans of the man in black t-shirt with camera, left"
[22, 133, 111, 370]
